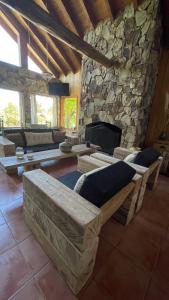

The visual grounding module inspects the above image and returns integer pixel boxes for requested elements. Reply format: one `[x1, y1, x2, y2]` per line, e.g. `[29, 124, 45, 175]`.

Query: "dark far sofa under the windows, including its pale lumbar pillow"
[1, 128, 65, 156]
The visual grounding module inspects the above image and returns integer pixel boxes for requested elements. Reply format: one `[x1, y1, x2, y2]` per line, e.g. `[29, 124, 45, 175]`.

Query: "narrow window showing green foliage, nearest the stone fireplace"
[62, 97, 78, 129]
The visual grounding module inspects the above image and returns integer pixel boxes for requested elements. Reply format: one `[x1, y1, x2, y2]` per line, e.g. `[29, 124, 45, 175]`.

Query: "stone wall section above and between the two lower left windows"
[0, 62, 55, 123]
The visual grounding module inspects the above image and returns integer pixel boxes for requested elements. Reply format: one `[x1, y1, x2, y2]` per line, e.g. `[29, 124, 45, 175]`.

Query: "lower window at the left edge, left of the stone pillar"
[0, 89, 21, 127]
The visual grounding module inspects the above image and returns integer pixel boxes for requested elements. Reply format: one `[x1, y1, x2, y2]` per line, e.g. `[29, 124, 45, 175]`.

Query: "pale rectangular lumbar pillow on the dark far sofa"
[25, 132, 53, 146]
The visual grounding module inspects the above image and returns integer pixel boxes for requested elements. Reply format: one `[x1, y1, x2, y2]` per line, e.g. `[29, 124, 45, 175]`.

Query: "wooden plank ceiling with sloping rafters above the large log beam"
[0, 0, 169, 77]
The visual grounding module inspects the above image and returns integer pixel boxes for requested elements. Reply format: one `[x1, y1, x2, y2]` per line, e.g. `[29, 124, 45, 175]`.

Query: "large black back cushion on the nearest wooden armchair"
[79, 161, 136, 207]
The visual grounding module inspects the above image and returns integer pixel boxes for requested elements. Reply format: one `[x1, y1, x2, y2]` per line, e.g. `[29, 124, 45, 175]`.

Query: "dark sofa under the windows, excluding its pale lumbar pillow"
[1, 128, 65, 156]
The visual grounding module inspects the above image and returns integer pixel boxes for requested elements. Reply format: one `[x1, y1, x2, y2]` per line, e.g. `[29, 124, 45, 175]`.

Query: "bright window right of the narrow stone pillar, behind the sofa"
[31, 95, 59, 127]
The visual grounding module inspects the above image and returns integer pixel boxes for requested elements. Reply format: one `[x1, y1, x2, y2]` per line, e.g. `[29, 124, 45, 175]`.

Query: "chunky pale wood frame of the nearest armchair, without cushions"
[23, 170, 141, 294]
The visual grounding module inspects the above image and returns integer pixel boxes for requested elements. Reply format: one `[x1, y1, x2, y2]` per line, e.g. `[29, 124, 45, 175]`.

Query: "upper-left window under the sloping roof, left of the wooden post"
[0, 26, 20, 66]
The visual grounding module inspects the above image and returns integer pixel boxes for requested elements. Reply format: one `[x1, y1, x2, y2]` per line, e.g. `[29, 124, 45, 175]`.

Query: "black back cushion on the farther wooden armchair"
[134, 148, 160, 168]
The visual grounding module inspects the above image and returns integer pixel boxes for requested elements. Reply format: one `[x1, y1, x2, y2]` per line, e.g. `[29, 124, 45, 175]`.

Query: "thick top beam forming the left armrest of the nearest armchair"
[23, 170, 101, 251]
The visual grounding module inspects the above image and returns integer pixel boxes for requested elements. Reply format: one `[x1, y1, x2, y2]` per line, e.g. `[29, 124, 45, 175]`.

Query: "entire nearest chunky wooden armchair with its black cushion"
[23, 162, 141, 294]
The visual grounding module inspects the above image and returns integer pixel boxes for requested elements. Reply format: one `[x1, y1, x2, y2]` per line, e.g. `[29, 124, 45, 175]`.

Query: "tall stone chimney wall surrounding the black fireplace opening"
[80, 0, 161, 147]
